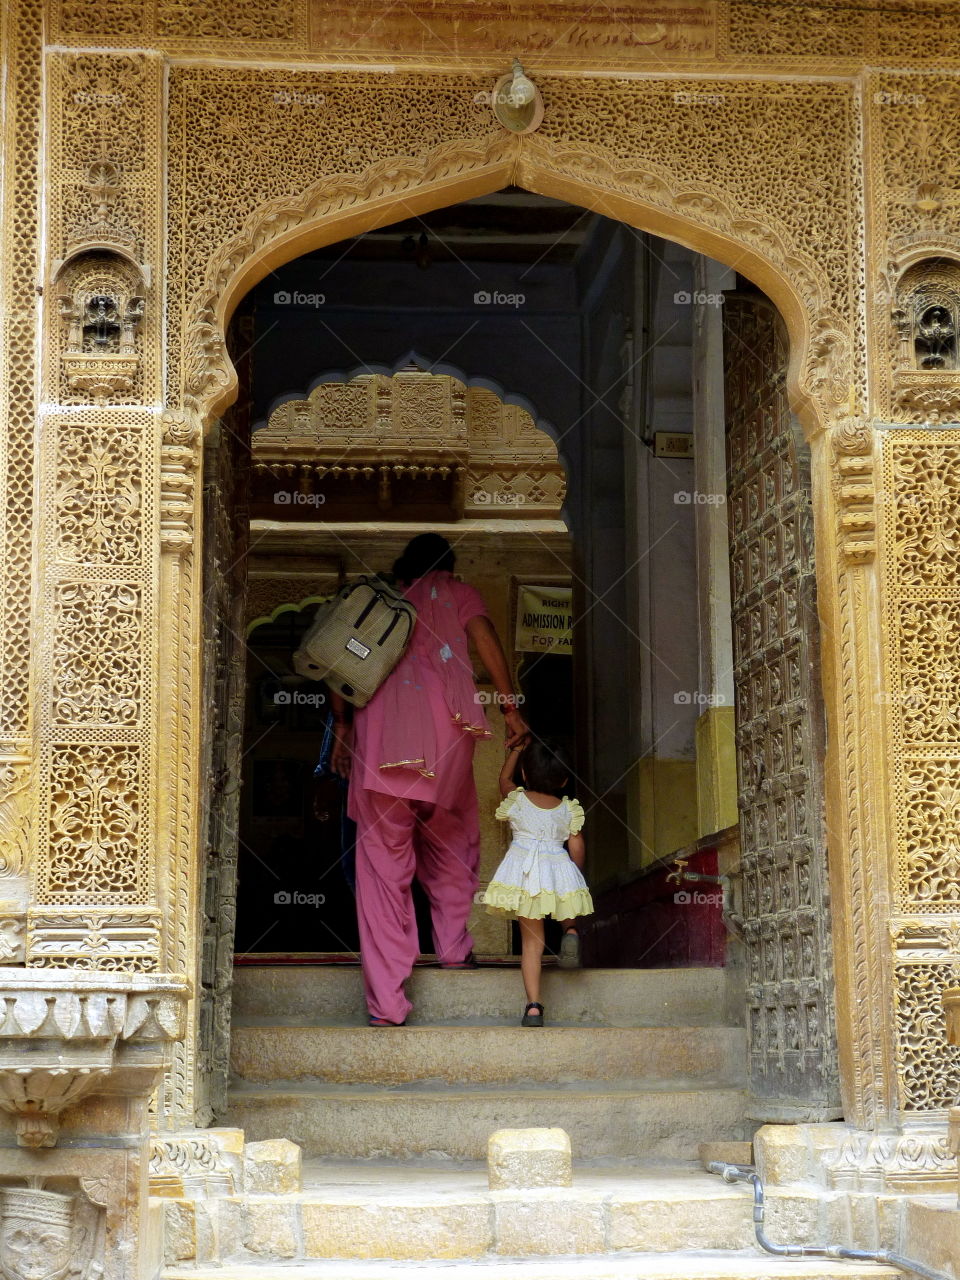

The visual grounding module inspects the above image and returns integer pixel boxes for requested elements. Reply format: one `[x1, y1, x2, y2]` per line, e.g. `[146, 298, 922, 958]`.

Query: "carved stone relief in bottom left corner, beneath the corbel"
[0, 1187, 83, 1280]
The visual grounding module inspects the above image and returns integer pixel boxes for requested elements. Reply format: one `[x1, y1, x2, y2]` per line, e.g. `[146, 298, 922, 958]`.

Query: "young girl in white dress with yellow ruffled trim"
[480, 741, 594, 1027]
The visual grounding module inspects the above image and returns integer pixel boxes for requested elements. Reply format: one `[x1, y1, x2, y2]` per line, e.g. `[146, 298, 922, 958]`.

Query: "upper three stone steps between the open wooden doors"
[227, 968, 748, 1161]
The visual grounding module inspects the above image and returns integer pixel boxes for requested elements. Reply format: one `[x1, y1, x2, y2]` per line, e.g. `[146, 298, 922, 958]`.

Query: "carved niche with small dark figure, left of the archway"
[56, 250, 146, 404]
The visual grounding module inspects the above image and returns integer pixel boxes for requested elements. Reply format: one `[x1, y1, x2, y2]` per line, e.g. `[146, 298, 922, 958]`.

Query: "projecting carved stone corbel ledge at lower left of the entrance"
[0, 968, 187, 1147]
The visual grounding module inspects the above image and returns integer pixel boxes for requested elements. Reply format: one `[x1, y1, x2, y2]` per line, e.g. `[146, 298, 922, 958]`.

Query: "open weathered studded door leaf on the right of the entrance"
[723, 297, 840, 1120]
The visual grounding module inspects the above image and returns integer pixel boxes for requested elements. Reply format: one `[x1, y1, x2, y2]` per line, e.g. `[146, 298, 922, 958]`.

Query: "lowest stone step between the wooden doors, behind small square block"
[224, 1080, 755, 1160]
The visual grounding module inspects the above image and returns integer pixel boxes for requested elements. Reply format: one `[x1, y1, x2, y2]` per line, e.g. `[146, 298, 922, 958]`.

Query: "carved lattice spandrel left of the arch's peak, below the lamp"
[166, 67, 512, 404]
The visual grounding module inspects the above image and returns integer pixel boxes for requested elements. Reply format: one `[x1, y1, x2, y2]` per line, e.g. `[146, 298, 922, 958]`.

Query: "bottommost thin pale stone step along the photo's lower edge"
[161, 1253, 906, 1280]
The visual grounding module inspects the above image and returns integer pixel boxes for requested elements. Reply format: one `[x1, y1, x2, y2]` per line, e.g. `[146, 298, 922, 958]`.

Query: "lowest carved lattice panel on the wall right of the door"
[895, 963, 960, 1111]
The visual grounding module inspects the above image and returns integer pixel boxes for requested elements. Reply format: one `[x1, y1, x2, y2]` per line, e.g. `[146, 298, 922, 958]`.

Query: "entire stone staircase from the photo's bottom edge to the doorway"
[154, 966, 911, 1280]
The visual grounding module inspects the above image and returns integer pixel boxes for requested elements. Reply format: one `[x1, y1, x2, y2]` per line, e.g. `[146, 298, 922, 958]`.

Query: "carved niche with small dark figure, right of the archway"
[891, 257, 960, 424]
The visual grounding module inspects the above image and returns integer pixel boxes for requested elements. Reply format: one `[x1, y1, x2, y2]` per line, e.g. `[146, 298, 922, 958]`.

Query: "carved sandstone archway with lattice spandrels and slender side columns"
[39, 63, 893, 1124]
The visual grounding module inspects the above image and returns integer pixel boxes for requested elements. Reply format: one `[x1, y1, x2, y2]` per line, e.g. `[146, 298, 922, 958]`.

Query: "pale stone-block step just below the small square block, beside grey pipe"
[154, 1161, 880, 1265]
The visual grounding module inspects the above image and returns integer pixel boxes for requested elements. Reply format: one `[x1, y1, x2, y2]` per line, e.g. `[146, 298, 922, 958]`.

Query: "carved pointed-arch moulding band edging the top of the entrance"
[156, 102, 865, 1121]
